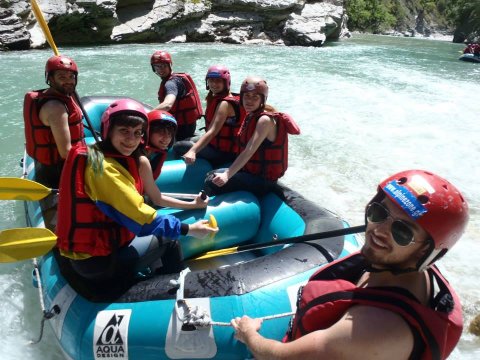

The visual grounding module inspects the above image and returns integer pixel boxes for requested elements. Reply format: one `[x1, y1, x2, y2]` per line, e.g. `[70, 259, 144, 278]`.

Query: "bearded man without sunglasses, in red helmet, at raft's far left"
[23, 56, 84, 229]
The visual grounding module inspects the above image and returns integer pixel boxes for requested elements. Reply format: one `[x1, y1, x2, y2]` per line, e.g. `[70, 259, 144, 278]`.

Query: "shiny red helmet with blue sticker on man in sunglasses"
[378, 170, 468, 267]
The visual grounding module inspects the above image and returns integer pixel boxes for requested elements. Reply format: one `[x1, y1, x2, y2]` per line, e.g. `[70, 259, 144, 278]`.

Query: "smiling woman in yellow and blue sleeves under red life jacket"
[56, 99, 218, 287]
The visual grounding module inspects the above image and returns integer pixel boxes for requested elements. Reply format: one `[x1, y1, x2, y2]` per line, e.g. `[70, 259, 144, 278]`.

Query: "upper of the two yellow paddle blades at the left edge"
[0, 177, 52, 201]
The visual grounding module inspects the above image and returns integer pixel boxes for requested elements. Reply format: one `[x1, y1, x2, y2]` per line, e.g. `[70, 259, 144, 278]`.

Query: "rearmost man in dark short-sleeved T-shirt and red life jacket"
[150, 50, 203, 140]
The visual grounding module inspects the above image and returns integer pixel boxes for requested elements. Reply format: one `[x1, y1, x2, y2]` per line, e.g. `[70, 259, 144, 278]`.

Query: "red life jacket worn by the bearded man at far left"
[23, 90, 84, 165]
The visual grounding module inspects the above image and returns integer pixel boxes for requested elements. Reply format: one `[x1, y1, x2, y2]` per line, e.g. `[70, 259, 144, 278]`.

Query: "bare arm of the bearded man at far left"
[39, 100, 72, 159]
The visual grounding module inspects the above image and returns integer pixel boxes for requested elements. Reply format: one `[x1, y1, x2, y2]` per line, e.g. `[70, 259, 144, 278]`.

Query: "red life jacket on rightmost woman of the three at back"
[238, 112, 300, 181]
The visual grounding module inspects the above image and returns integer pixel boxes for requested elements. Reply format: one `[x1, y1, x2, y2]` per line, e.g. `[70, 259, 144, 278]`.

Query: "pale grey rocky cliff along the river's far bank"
[0, 0, 349, 50]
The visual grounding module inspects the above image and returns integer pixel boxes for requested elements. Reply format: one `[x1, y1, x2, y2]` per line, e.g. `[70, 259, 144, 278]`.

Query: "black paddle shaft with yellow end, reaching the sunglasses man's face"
[196, 225, 366, 260]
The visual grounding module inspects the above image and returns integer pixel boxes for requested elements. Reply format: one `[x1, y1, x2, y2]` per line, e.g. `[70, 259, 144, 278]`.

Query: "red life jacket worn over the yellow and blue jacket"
[56, 145, 143, 256]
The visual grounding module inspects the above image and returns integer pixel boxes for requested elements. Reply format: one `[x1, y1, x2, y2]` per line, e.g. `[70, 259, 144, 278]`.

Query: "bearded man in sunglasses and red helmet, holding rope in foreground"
[231, 170, 468, 360]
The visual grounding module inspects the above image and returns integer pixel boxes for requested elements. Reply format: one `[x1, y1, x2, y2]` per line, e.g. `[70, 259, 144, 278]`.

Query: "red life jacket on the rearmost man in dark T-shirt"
[158, 73, 203, 125]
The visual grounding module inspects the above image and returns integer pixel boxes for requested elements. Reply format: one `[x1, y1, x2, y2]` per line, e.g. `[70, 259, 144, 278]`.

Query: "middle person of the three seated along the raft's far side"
[173, 65, 245, 168]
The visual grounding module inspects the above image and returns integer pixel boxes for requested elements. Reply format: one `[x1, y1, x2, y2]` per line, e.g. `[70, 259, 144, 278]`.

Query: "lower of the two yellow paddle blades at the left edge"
[0, 228, 57, 262]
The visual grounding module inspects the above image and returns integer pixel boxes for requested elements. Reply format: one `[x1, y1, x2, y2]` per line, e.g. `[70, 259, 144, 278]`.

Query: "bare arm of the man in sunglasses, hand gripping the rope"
[232, 306, 413, 360]
